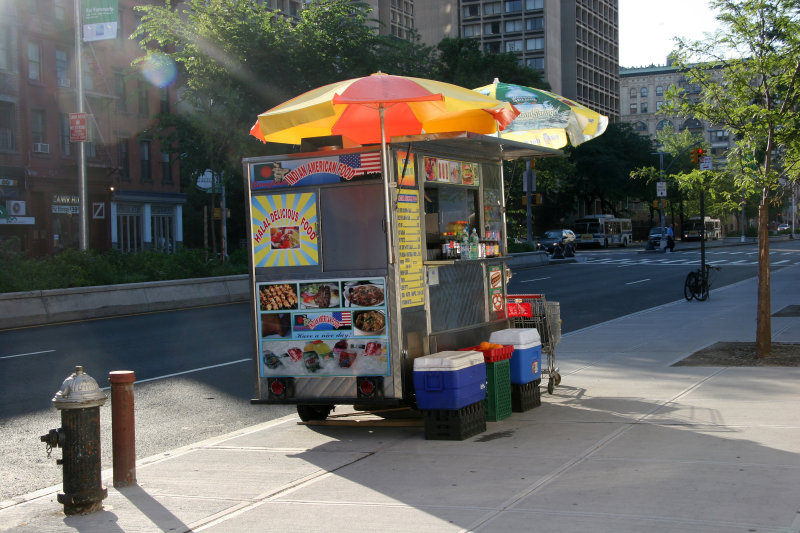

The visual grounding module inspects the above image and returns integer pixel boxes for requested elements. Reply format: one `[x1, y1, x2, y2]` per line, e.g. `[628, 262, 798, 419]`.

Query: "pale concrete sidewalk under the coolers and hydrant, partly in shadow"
[0, 267, 800, 533]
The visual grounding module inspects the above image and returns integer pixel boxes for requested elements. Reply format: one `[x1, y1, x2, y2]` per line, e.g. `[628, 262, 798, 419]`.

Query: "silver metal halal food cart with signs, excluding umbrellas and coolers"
[243, 133, 560, 420]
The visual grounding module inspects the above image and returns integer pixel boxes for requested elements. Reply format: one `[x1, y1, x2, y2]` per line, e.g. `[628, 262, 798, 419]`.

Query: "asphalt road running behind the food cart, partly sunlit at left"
[0, 241, 800, 501]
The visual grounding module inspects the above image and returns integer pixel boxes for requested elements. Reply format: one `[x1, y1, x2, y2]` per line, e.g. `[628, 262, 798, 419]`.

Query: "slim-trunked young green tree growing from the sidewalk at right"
[666, 0, 800, 358]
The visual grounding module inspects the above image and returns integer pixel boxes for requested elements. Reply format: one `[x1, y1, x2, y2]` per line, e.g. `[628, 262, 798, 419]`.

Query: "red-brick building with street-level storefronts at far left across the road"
[0, 0, 186, 256]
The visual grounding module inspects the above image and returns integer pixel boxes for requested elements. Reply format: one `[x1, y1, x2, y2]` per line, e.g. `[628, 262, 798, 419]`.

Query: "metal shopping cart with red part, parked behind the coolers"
[506, 294, 561, 394]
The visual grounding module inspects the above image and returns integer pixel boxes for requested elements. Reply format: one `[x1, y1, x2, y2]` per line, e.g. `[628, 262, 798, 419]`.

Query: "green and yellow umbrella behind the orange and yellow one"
[473, 78, 608, 148]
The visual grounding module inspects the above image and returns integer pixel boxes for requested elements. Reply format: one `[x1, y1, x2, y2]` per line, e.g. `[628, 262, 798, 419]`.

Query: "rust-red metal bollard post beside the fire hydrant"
[108, 370, 136, 487]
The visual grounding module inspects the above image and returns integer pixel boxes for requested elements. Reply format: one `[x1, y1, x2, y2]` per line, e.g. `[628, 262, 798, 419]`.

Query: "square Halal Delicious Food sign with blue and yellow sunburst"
[255, 192, 319, 267]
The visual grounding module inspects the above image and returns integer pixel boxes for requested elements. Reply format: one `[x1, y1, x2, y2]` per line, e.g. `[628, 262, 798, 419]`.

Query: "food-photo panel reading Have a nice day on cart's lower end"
[257, 278, 389, 378]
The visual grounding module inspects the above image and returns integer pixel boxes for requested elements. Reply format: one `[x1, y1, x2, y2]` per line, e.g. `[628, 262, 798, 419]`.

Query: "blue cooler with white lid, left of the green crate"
[414, 352, 484, 410]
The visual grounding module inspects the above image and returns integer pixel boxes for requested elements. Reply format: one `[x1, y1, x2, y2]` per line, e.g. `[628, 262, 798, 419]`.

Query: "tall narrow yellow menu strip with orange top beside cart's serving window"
[397, 152, 425, 308]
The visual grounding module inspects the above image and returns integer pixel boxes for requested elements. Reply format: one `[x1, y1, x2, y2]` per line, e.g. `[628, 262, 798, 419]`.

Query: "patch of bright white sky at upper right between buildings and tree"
[619, 0, 717, 67]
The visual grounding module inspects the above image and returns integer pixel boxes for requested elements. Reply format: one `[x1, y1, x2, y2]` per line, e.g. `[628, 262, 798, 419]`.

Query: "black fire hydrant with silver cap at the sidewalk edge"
[41, 366, 108, 515]
